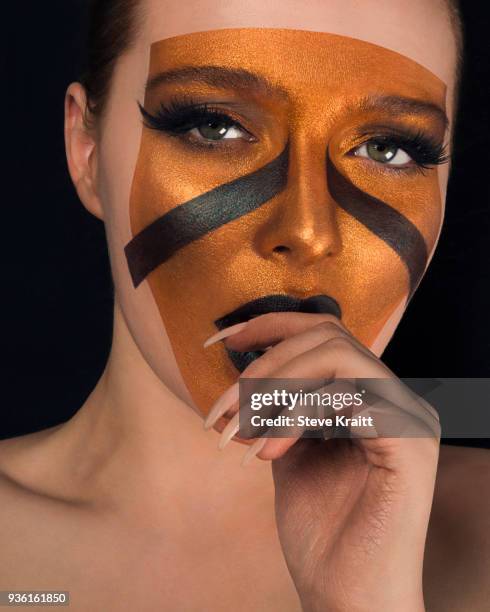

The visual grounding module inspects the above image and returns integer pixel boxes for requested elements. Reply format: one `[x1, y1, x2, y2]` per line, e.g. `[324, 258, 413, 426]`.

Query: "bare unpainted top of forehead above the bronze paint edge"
[140, 0, 456, 88]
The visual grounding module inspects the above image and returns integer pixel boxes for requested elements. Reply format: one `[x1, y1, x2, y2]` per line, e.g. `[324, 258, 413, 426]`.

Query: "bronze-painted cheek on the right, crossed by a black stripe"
[327, 153, 442, 346]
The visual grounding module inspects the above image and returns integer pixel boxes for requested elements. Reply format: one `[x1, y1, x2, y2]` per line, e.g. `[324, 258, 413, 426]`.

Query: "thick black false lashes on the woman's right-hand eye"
[356, 131, 449, 170]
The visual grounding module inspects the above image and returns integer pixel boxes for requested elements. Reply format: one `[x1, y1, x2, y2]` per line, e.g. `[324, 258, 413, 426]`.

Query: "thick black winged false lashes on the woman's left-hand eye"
[138, 99, 247, 135]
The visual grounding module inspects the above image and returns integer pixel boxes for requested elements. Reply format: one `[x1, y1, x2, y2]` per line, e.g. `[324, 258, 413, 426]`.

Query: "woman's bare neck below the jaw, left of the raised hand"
[38, 306, 272, 518]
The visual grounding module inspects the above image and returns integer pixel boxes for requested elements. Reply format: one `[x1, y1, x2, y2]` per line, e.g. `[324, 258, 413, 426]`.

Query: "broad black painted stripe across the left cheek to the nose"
[124, 145, 289, 287]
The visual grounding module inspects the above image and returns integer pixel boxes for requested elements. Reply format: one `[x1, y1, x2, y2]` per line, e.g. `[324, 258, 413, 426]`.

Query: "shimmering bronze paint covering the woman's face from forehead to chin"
[126, 29, 445, 412]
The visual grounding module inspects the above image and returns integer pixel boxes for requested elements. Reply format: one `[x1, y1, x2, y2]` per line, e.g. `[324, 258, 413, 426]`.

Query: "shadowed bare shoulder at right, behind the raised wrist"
[424, 445, 490, 612]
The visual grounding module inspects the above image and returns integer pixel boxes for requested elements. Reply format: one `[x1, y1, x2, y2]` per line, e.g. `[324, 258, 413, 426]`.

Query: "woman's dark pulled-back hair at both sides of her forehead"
[80, 0, 463, 123]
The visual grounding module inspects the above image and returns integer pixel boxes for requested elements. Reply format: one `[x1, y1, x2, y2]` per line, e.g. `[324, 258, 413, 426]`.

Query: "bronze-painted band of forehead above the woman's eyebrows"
[148, 28, 446, 107]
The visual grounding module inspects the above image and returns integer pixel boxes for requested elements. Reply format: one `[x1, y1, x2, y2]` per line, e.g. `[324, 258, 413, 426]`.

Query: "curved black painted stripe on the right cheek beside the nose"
[327, 153, 429, 299]
